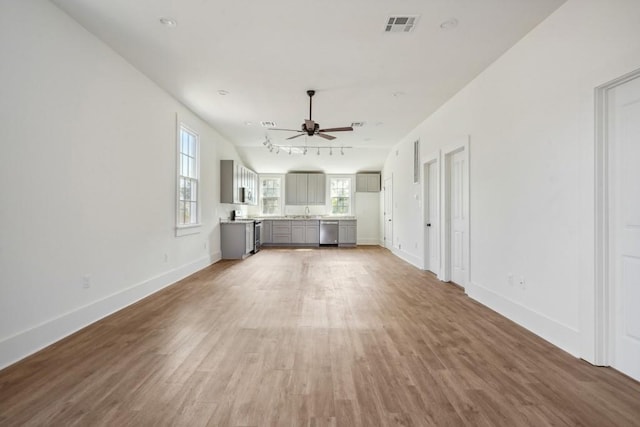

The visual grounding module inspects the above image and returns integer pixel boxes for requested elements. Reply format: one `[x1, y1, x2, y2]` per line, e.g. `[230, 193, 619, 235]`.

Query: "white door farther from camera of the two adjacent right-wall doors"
[423, 161, 440, 275]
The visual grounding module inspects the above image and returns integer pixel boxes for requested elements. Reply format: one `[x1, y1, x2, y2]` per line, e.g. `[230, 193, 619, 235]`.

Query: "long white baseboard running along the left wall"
[0, 252, 221, 369]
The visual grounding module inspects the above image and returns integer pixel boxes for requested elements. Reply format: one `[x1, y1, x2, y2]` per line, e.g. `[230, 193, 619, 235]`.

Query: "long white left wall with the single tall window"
[0, 0, 242, 368]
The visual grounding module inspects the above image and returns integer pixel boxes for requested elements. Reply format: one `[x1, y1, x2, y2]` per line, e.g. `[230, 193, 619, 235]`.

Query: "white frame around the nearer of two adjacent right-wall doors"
[438, 135, 471, 290]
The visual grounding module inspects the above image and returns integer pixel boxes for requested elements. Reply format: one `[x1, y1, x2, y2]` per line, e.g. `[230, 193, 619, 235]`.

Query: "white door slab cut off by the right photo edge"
[608, 73, 640, 381]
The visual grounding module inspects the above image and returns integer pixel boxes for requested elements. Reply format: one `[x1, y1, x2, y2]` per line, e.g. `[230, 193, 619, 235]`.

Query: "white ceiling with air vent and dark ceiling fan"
[52, 0, 565, 173]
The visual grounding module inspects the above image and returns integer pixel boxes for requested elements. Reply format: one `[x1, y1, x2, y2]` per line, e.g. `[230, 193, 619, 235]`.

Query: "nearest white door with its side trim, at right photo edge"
[595, 70, 640, 380]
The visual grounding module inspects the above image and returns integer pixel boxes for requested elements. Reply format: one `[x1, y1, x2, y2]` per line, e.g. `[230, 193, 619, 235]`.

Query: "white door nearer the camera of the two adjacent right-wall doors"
[449, 150, 467, 287]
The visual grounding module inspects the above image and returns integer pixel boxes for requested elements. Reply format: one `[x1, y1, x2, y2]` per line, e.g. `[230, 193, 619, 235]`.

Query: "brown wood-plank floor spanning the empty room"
[0, 248, 640, 427]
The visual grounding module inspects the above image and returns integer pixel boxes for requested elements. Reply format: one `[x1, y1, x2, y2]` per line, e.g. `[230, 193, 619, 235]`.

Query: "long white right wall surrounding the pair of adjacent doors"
[384, 0, 640, 360]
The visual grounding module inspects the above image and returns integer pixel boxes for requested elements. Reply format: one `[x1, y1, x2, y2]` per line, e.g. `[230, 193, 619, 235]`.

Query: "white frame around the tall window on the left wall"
[175, 120, 202, 237]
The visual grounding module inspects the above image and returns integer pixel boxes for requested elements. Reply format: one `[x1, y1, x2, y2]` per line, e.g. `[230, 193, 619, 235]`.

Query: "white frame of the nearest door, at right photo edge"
[592, 69, 640, 366]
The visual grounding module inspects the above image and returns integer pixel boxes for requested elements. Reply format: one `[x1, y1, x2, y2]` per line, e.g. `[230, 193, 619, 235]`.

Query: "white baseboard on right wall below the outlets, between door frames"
[465, 283, 580, 357]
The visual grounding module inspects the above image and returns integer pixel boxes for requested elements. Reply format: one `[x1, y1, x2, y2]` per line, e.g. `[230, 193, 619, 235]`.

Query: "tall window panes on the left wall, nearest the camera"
[177, 124, 200, 227]
